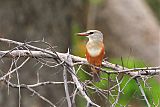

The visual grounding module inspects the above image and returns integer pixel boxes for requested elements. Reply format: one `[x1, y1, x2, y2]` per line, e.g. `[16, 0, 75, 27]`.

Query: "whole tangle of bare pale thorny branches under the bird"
[0, 38, 160, 107]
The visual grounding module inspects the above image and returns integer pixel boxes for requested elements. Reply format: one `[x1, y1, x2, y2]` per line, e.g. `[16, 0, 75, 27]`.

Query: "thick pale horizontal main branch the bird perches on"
[0, 50, 160, 76]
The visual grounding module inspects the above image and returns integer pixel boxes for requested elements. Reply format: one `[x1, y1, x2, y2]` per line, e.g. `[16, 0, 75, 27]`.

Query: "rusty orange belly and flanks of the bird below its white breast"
[86, 43, 105, 66]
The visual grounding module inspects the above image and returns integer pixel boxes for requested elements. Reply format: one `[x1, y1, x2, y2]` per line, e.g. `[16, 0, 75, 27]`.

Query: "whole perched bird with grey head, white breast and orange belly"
[77, 30, 105, 82]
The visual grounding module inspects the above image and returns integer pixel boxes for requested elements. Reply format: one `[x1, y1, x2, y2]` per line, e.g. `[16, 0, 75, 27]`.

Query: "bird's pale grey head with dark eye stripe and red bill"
[77, 30, 103, 41]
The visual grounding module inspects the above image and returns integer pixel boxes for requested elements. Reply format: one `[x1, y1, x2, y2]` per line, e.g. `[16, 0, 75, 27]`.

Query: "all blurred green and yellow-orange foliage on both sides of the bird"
[72, 20, 160, 107]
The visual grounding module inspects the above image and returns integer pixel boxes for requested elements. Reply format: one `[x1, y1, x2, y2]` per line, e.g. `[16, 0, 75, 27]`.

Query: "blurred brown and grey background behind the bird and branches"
[0, 0, 160, 107]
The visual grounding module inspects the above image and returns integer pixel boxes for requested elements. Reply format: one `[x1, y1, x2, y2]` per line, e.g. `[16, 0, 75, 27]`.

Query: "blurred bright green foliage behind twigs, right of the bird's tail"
[85, 58, 160, 107]
